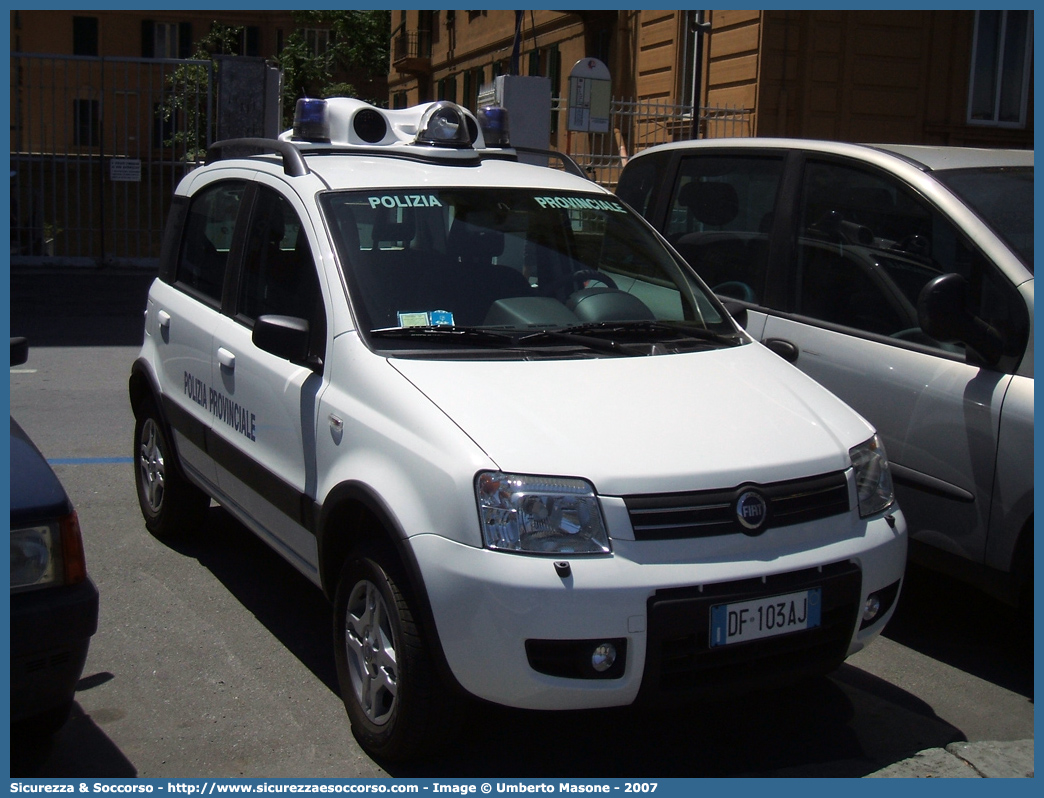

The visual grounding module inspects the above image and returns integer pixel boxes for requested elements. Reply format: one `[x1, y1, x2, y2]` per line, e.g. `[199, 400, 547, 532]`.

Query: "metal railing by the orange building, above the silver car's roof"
[551, 97, 752, 189]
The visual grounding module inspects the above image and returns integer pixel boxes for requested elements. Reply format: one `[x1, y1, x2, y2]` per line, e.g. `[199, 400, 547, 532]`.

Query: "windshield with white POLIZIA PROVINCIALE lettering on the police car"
[321, 188, 741, 355]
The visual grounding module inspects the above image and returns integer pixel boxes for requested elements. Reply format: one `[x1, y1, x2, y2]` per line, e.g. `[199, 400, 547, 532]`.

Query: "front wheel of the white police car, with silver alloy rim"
[333, 554, 449, 761]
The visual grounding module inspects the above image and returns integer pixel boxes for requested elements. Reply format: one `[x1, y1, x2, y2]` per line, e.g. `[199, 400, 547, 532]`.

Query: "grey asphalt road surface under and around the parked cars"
[9, 273, 1034, 778]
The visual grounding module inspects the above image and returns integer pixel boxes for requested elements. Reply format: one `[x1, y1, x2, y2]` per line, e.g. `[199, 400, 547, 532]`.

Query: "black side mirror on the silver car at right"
[917, 273, 1004, 366]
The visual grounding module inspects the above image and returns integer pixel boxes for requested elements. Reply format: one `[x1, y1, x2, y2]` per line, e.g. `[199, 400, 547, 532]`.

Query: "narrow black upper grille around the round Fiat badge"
[623, 471, 849, 540]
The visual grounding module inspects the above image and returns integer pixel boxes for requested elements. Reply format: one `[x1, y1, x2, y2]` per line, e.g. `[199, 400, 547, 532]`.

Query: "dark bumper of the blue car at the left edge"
[10, 579, 98, 722]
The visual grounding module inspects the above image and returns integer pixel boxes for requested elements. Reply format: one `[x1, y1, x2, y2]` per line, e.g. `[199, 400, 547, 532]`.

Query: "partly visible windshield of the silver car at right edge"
[935, 166, 1034, 272]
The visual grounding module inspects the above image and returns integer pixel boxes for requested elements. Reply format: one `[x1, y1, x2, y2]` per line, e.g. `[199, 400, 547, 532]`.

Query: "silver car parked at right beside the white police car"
[617, 139, 1034, 607]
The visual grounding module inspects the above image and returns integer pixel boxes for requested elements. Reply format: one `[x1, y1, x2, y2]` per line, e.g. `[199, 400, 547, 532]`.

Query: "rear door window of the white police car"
[174, 182, 245, 305]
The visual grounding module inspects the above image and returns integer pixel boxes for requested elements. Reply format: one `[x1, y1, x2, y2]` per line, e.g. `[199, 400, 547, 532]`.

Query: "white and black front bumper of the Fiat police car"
[408, 511, 906, 709]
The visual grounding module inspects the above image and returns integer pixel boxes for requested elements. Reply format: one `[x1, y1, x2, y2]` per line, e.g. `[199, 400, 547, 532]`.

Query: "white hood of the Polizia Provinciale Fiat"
[392, 344, 873, 495]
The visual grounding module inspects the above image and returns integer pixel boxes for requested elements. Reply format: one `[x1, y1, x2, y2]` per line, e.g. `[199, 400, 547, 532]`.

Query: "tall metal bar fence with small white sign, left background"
[10, 53, 213, 264]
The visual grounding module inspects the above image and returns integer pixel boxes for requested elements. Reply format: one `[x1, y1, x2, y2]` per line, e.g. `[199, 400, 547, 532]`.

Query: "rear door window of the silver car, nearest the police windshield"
[664, 155, 783, 304]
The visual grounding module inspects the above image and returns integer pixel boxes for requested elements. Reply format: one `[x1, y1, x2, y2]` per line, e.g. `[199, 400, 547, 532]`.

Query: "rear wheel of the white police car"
[134, 399, 210, 540]
